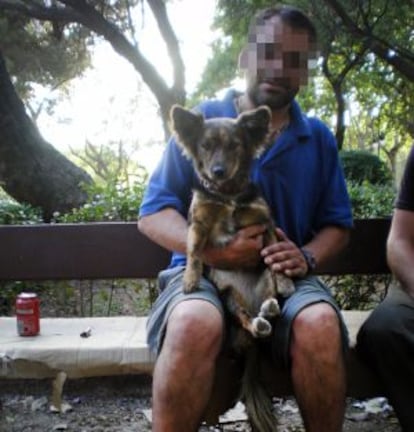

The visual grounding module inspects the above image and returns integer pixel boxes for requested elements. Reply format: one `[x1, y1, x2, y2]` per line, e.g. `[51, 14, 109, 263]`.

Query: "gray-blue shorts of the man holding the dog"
[147, 267, 349, 366]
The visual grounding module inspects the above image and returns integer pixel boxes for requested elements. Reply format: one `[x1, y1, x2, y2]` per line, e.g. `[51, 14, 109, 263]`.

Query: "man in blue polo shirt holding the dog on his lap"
[138, 7, 352, 432]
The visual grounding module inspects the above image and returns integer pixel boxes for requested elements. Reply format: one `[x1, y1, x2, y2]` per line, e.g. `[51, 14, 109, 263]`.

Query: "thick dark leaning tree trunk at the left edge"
[0, 52, 92, 220]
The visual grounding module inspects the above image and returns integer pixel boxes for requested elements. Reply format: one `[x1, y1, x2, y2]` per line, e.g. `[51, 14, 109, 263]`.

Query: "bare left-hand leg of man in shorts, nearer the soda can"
[152, 300, 224, 432]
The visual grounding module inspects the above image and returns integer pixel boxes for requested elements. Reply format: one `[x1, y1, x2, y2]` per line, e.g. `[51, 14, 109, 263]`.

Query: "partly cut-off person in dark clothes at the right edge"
[357, 147, 414, 432]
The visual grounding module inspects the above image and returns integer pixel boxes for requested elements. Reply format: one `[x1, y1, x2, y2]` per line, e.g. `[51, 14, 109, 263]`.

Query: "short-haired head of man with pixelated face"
[239, 6, 316, 110]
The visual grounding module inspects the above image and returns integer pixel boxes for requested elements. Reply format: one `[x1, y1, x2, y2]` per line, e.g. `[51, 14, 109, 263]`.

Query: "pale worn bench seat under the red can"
[0, 311, 379, 397]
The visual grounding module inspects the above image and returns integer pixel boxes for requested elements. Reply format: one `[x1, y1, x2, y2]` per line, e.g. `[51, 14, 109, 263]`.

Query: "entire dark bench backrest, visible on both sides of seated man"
[0, 219, 390, 280]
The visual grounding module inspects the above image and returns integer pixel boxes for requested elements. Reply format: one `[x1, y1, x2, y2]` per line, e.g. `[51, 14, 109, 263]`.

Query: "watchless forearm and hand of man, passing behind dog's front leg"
[138, 208, 265, 268]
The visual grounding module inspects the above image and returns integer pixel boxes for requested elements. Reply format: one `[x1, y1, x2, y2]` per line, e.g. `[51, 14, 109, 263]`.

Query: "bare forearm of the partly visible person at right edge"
[387, 209, 414, 298]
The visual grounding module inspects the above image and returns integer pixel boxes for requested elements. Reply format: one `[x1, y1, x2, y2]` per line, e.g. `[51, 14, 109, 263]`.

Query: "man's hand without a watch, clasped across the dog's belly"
[203, 225, 266, 269]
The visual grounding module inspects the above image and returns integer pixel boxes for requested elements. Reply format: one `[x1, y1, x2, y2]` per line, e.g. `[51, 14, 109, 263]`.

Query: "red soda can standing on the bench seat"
[16, 292, 40, 336]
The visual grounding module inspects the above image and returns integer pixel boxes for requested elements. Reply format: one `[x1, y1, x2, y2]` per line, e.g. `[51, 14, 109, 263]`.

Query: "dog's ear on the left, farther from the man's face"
[170, 105, 204, 155]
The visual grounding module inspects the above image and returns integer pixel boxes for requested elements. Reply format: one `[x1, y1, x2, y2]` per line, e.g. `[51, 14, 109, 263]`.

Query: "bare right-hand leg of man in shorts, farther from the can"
[290, 303, 346, 432]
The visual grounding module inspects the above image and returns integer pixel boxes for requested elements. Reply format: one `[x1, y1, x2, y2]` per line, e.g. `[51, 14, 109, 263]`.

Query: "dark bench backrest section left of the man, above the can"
[0, 223, 169, 280]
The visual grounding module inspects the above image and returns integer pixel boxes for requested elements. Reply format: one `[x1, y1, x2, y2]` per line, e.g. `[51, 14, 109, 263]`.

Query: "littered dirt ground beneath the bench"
[0, 376, 401, 432]
